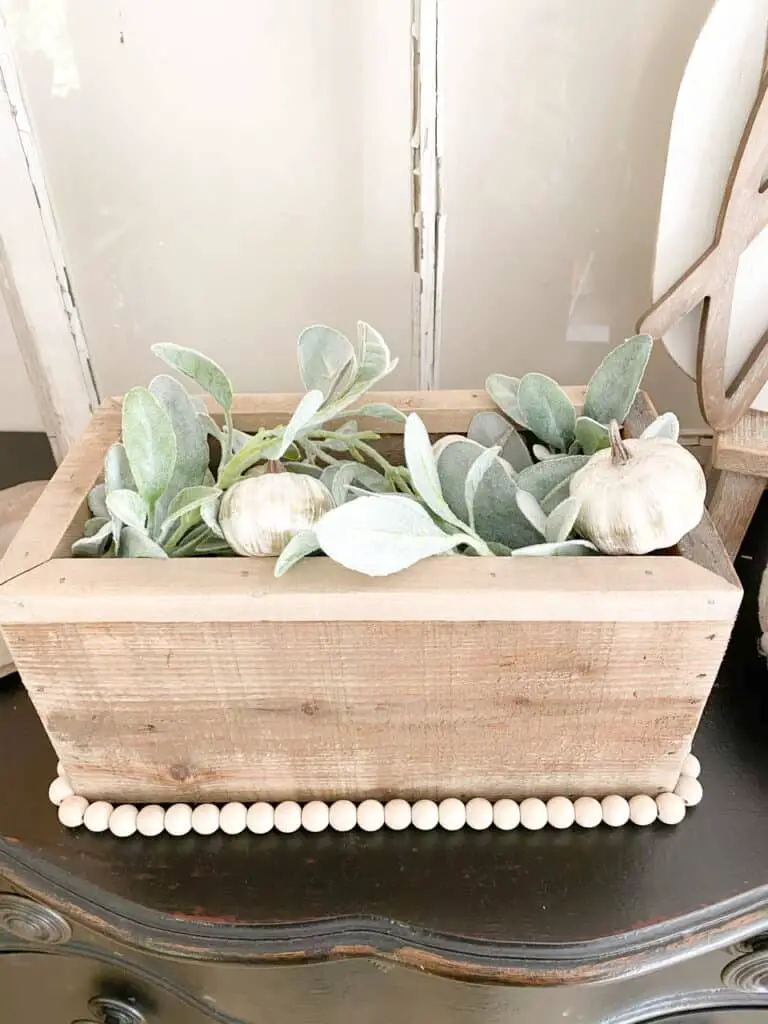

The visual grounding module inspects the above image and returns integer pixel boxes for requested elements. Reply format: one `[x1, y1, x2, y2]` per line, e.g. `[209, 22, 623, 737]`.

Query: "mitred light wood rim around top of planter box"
[0, 387, 741, 625]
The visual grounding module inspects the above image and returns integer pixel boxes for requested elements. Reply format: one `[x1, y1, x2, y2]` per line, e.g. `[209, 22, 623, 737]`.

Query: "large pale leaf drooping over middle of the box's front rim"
[314, 493, 467, 577]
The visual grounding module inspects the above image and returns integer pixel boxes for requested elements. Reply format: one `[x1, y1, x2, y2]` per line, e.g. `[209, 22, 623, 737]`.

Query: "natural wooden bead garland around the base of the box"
[48, 754, 703, 838]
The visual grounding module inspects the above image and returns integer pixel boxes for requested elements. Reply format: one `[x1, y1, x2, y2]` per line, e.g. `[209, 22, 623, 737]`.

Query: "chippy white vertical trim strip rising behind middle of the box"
[411, 0, 445, 389]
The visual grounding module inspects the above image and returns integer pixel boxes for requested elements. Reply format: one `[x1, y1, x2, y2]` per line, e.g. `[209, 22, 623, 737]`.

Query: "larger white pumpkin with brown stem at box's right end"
[570, 421, 707, 555]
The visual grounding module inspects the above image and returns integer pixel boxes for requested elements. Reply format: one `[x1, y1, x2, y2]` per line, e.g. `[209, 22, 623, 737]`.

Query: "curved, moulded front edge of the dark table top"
[0, 839, 768, 987]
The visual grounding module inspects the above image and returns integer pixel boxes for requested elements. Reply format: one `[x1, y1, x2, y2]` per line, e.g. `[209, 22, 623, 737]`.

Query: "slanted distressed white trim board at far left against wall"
[0, 18, 98, 461]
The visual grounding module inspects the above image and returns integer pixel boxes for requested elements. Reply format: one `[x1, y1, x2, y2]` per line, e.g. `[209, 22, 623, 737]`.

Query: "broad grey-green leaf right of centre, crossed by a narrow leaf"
[434, 436, 539, 548]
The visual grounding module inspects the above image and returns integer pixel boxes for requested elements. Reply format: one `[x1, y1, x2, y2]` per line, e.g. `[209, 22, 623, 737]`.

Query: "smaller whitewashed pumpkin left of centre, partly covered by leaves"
[219, 471, 334, 557]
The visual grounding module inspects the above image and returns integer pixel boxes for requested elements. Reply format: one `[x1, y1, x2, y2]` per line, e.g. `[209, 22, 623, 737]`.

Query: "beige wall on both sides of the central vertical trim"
[0, 0, 711, 426]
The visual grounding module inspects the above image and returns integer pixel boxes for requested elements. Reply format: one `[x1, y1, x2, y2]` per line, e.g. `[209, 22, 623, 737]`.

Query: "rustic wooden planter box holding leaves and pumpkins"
[0, 389, 741, 802]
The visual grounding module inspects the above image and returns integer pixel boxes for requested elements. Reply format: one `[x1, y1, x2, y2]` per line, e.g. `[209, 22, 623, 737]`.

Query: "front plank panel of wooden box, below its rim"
[7, 622, 730, 801]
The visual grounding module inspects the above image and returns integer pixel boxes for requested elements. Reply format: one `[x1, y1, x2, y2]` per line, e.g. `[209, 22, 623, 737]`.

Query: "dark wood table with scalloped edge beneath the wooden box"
[0, 493, 768, 1024]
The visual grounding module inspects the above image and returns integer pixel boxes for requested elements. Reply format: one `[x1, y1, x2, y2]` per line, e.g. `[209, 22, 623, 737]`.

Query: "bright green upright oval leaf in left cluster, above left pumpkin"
[121, 387, 176, 509]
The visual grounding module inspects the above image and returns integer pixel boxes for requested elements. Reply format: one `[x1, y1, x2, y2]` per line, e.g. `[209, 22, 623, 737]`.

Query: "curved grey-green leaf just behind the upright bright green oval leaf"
[150, 374, 210, 521]
